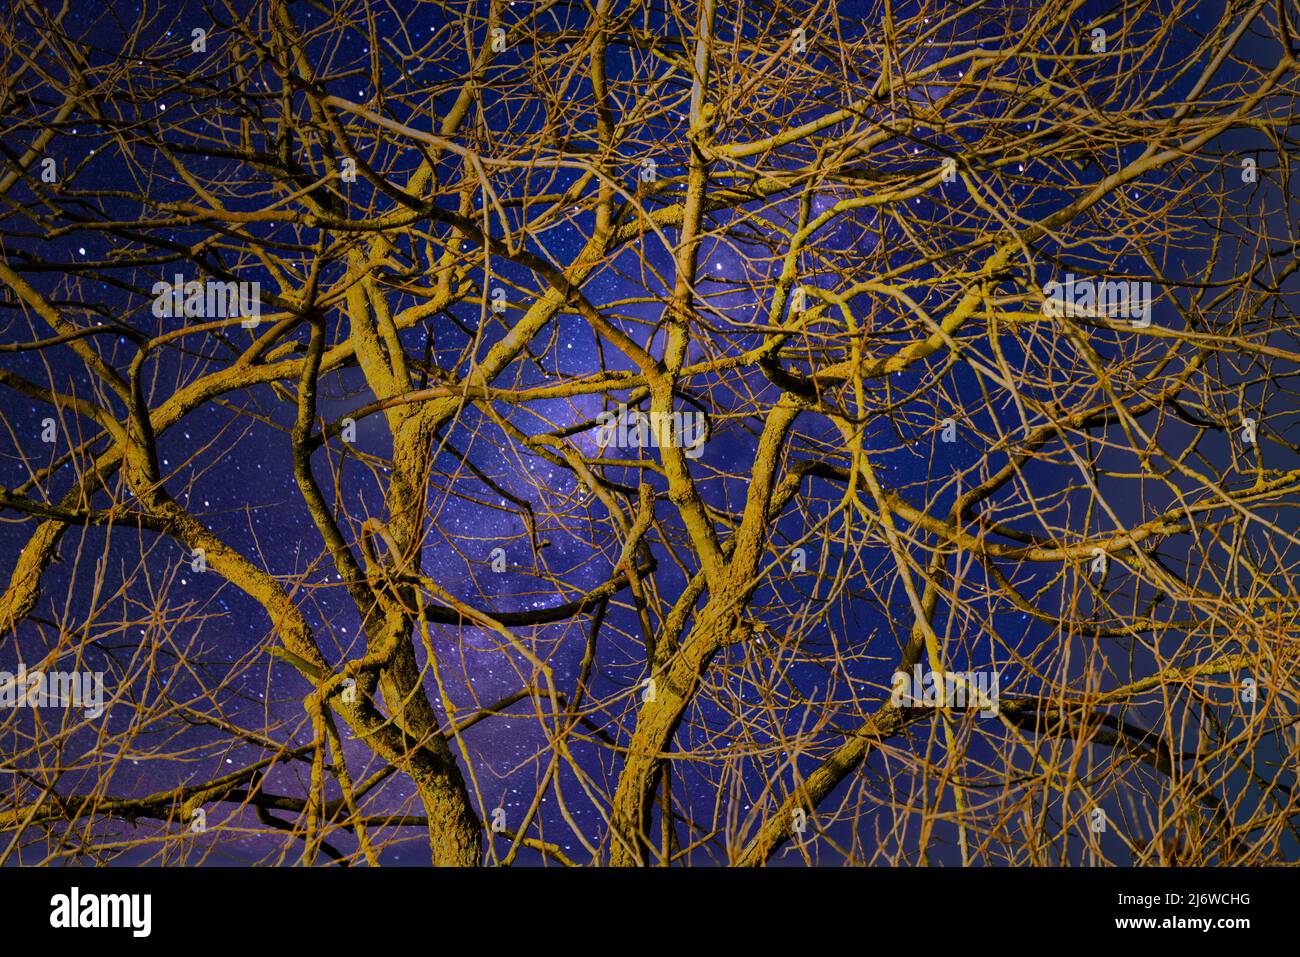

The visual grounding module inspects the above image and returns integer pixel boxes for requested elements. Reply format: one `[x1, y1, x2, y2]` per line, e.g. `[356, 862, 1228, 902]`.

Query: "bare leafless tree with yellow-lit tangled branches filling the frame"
[0, 0, 1300, 865]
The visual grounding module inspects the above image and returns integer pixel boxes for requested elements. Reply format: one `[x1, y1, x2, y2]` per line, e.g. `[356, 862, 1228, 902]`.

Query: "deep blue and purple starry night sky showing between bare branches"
[0, 0, 1294, 863]
